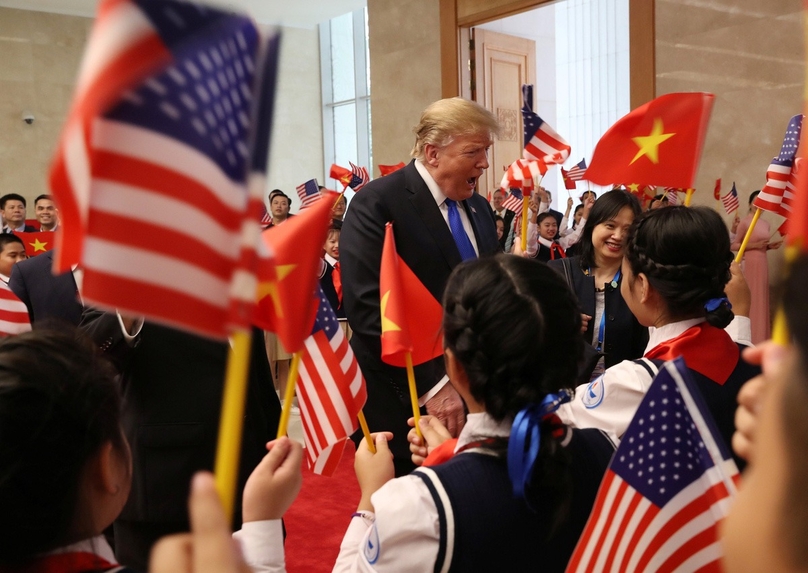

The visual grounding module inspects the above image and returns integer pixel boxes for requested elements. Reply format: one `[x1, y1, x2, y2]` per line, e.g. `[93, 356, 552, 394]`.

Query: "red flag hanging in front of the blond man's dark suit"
[379, 223, 443, 367]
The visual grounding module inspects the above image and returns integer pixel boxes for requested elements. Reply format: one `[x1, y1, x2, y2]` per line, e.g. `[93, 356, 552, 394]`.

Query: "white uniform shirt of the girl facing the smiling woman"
[557, 316, 752, 445]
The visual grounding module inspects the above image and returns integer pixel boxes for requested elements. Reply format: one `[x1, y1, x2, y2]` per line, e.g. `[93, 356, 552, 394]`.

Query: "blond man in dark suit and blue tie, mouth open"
[340, 98, 499, 475]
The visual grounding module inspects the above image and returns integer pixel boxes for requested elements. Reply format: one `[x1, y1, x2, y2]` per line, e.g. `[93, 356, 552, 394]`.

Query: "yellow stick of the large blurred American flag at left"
[215, 331, 252, 521]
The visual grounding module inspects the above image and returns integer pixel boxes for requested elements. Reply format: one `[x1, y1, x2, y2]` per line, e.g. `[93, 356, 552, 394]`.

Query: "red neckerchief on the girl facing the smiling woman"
[645, 322, 740, 385]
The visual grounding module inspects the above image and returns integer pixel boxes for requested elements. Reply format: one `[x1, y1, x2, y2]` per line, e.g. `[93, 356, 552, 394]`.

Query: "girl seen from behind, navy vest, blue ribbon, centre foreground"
[334, 255, 613, 571]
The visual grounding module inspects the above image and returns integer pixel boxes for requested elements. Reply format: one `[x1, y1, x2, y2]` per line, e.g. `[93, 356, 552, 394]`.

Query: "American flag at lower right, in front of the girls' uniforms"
[567, 358, 739, 572]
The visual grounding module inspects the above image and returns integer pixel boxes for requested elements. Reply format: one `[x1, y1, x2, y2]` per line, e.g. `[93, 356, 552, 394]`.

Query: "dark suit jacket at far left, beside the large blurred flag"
[8, 251, 82, 328]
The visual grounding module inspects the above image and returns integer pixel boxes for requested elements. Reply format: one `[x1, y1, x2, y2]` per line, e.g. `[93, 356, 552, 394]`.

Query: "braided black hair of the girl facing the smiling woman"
[625, 206, 734, 328]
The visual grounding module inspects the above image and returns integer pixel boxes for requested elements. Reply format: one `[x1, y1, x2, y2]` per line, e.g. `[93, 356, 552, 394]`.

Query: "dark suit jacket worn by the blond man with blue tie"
[340, 162, 498, 460]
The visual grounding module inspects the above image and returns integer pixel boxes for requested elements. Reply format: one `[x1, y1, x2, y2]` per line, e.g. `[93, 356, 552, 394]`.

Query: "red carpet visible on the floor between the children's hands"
[283, 440, 360, 573]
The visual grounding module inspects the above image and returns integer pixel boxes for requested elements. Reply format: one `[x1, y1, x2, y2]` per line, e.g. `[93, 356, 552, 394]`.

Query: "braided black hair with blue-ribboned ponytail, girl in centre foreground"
[443, 254, 585, 535]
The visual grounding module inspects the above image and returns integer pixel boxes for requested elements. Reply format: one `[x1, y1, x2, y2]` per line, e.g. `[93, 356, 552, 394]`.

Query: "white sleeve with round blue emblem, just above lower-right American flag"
[558, 360, 652, 444]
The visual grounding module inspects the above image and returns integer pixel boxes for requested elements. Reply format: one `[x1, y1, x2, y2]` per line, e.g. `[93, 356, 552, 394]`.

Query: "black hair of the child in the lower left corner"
[0, 330, 126, 564]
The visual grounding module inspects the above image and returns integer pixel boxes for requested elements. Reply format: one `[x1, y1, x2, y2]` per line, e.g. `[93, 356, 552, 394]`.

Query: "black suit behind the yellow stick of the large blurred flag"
[80, 308, 280, 523]
